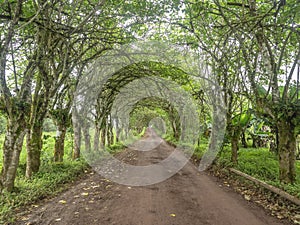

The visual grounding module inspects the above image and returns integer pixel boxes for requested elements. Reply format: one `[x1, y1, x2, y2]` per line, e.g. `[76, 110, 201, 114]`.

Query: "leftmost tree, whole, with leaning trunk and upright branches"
[0, 0, 34, 191]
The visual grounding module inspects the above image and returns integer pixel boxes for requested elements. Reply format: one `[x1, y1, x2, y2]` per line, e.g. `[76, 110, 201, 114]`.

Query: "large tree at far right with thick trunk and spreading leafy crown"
[178, 0, 300, 183]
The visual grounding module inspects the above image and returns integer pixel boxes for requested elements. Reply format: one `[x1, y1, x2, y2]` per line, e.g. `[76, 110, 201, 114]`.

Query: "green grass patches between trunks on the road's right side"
[165, 135, 300, 198]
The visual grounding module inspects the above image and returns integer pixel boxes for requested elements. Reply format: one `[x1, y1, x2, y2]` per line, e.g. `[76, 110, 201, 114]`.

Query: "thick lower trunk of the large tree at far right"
[278, 121, 296, 183]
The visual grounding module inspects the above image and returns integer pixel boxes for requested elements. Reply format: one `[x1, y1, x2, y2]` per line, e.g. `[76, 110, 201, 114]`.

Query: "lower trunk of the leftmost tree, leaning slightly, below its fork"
[0, 119, 26, 191]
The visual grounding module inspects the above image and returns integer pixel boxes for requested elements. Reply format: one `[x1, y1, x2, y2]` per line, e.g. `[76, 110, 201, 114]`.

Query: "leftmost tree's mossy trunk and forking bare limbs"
[0, 0, 24, 192]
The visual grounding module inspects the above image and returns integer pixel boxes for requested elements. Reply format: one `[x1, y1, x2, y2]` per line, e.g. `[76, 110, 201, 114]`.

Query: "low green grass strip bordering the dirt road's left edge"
[0, 160, 88, 224]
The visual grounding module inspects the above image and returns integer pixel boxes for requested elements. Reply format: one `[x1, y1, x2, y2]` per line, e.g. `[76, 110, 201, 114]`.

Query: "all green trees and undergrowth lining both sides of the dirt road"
[0, 0, 300, 223]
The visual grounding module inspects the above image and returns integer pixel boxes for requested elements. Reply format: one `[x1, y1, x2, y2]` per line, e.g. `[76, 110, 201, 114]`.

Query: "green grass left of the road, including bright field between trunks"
[0, 132, 88, 224]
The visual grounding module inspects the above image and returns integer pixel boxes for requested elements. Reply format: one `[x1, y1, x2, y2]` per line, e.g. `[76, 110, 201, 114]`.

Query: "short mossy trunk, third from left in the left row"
[54, 124, 67, 162]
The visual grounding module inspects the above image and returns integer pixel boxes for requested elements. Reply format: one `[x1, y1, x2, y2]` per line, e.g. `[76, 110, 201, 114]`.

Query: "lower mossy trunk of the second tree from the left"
[26, 121, 43, 178]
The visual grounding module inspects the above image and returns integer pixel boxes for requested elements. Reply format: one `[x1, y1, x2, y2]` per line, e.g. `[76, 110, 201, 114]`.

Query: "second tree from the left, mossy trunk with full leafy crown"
[26, 1, 122, 177]
